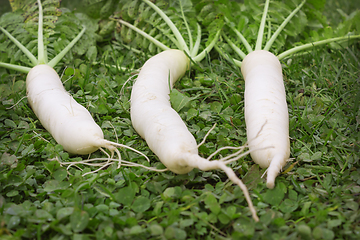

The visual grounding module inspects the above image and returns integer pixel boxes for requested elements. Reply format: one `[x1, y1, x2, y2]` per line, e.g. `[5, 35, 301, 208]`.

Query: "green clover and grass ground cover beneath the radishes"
[0, 1, 360, 239]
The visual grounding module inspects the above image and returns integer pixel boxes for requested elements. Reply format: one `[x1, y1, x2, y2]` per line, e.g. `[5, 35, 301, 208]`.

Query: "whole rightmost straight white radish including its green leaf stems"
[216, 0, 360, 188]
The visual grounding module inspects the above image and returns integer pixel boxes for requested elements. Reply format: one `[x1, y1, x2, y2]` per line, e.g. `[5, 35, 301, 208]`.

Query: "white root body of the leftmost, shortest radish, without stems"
[26, 64, 114, 155]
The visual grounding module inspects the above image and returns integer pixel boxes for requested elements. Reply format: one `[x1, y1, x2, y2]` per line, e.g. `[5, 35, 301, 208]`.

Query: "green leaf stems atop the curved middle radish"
[113, 0, 221, 62]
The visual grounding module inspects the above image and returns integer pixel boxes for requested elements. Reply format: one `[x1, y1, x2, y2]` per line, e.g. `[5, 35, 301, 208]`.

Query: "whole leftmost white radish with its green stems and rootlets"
[0, 0, 147, 162]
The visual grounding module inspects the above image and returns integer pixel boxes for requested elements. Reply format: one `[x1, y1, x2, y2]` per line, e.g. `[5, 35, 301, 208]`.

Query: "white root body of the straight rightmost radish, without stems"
[241, 50, 290, 188]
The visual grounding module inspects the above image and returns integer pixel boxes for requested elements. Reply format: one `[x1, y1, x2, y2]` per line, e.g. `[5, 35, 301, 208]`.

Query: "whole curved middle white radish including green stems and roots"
[121, 0, 259, 221]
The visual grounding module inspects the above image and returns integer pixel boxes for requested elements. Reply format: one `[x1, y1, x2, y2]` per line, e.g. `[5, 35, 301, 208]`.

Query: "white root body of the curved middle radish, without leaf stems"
[130, 50, 258, 221]
